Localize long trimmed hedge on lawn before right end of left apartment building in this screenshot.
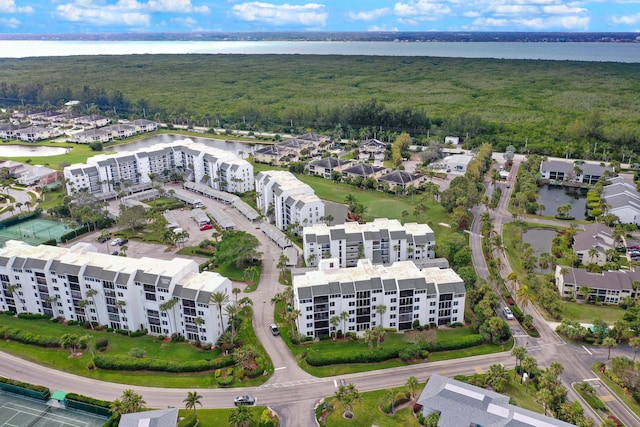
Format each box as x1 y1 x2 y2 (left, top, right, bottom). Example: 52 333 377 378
94 354 234 372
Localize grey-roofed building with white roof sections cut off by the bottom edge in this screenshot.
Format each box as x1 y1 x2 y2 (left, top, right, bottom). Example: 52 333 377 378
418 374 575 427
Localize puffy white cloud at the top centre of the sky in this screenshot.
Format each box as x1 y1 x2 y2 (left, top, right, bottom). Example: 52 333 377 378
232 2 328 27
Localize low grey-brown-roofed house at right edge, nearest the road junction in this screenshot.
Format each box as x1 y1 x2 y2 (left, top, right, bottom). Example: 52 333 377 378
555 265 640 304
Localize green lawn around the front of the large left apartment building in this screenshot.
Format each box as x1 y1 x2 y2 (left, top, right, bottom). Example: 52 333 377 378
0 310 273 388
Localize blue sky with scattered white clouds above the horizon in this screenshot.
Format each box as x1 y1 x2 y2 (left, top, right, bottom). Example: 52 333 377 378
0 0 640 34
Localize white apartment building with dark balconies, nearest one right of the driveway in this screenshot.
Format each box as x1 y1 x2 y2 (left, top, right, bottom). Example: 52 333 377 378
293 259 466 337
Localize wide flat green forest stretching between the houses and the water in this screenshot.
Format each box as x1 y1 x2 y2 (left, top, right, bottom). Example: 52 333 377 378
0 54 640 160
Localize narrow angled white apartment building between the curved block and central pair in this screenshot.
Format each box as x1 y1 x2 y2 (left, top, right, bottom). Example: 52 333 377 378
256 171 324 230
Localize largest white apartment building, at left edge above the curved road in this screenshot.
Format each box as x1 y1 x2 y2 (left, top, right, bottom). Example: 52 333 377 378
0 241 232 343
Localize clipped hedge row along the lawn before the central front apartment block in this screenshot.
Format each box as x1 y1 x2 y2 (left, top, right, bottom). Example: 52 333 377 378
305 334 482 366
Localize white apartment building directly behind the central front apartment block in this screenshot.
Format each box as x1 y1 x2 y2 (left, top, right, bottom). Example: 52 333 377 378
302 218 436 268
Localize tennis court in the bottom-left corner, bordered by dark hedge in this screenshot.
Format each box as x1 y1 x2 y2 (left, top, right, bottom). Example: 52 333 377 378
0 392 107 427
